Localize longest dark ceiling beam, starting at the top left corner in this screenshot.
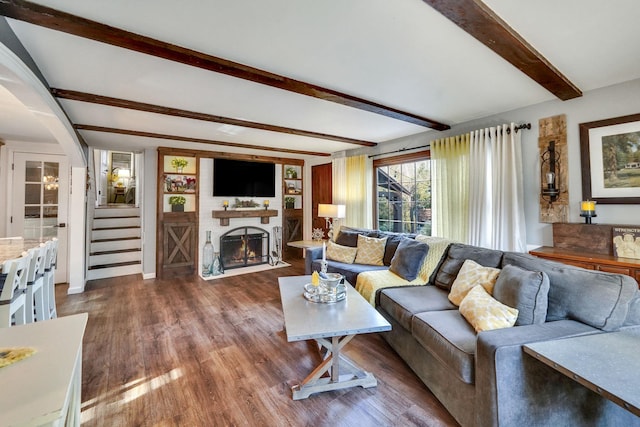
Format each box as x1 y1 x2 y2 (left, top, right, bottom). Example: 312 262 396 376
0 0 449 130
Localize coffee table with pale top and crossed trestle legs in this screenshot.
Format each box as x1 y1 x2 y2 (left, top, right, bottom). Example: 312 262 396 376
278 276 391 400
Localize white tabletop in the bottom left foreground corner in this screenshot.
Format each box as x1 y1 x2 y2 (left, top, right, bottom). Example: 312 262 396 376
0 313 88 426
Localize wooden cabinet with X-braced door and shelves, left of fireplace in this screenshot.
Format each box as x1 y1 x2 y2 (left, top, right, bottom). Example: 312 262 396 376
156 148 198 278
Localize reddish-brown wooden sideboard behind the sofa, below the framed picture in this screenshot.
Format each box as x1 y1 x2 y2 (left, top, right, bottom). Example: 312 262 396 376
529 246 640 286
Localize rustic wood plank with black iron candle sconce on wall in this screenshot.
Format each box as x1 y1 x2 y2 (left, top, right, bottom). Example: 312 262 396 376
538 114 569 223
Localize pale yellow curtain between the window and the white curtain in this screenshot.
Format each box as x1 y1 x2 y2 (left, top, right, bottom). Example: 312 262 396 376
431 133 470 243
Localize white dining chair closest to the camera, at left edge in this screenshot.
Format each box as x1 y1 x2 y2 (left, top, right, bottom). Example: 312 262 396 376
0 253 31 328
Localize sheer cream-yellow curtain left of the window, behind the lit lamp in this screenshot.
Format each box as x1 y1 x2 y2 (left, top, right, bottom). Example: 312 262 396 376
332 155 373 231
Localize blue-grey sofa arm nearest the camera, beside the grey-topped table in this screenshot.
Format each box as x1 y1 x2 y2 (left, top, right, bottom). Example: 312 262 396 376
475 320 607 426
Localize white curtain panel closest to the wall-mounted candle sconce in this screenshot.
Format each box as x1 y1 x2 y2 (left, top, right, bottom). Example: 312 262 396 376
469 123 526 252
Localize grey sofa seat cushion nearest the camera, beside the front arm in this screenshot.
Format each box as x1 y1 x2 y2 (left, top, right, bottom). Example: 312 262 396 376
412 310 476 384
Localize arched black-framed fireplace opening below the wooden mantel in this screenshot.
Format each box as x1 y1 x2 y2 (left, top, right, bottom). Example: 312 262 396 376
220 227 270 270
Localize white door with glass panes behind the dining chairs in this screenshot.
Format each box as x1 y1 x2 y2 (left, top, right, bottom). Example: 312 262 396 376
10 153 69 283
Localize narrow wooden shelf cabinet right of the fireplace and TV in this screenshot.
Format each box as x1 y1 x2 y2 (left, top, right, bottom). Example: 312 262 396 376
282 160 304 259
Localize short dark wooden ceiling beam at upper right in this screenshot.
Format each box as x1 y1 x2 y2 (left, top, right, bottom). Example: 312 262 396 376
423 0 582 101
